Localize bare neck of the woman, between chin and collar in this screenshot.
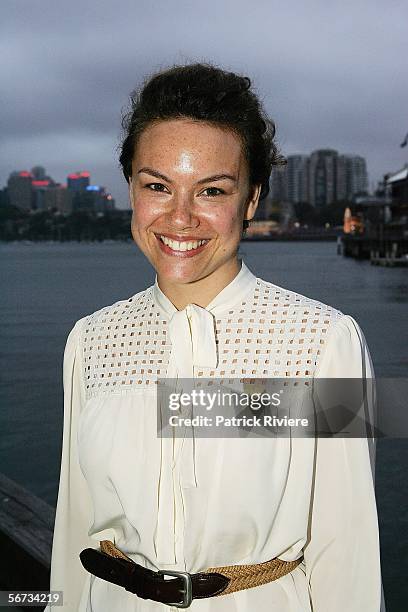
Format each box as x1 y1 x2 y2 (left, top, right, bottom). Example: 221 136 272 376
157 259 241 310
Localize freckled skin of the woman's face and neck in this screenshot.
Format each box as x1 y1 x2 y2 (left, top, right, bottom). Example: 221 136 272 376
129 119 260 310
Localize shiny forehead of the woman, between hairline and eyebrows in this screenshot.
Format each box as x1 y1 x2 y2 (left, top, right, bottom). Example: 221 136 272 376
133 119 246 173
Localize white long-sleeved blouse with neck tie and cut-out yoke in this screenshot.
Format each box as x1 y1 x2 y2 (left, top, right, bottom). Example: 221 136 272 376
46 262 381 612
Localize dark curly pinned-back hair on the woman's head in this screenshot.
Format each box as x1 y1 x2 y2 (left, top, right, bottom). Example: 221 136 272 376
119 63 286 230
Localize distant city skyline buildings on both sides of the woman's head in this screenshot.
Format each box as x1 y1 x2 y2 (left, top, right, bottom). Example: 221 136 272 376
0 147 369 212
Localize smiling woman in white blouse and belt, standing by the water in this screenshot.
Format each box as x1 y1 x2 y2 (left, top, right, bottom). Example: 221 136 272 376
45 64 381 612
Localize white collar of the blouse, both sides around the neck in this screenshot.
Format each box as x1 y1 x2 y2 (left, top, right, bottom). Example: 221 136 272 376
153 260 256 317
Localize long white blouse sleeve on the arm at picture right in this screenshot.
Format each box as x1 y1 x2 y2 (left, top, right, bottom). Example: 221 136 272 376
304 315 385 612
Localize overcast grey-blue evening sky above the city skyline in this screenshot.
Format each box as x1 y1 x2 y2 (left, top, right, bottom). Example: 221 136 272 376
0 0 408 208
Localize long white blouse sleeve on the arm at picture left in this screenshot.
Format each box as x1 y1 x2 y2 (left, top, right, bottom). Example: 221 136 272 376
45 319 95 612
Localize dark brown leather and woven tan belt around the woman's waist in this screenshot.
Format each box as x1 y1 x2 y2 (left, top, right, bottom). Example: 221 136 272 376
95 540 303 607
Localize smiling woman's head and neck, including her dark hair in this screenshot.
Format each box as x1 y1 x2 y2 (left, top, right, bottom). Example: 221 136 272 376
120 64 285 308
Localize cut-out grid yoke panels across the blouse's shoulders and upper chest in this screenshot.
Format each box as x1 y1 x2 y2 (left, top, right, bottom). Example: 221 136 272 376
82 279 343 398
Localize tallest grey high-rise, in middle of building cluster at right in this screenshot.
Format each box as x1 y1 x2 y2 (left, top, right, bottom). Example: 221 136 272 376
309 149 338 208
